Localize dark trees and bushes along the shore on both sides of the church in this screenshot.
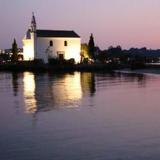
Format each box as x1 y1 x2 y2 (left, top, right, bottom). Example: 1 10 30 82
0 34 160 70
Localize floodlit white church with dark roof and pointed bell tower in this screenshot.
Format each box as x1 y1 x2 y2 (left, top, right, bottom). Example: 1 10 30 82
22 14 81 63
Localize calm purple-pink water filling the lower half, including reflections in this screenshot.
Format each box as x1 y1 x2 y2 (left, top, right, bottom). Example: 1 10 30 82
0 72 160 160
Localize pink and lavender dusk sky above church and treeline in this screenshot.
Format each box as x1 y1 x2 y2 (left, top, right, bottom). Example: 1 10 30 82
0 0 160 49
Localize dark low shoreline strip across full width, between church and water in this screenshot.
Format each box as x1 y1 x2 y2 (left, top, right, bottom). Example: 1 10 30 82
0 62 160 75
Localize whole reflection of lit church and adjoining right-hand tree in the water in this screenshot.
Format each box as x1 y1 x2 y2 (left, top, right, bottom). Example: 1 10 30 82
23 72 95 113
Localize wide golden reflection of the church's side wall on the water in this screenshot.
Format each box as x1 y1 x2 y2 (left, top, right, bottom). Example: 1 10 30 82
52 73 82 108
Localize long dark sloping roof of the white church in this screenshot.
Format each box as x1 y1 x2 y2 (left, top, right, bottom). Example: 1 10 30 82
36 30 80 38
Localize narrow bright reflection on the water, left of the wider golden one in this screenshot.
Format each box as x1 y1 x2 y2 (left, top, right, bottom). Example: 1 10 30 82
23 72 37 113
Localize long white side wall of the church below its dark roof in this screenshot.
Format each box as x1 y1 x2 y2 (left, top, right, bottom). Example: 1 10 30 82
36 37 81 63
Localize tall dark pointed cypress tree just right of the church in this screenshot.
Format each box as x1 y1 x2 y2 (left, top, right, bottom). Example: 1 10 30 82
88 34 95 59
